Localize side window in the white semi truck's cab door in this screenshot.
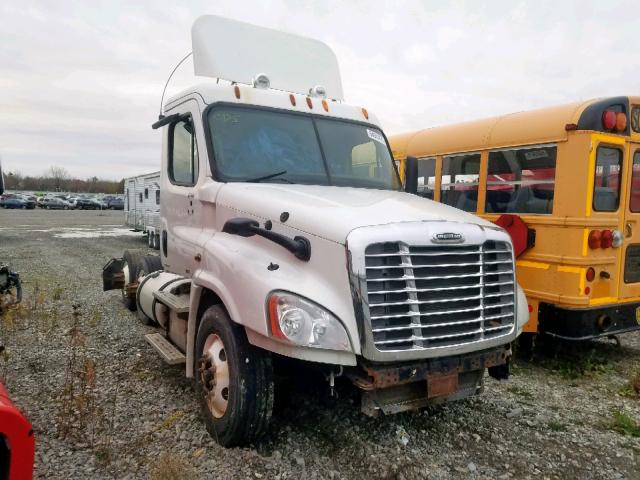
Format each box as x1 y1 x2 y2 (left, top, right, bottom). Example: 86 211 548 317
169 121 198 186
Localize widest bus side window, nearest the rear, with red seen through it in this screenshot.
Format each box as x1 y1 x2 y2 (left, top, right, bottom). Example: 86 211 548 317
485 146 557 214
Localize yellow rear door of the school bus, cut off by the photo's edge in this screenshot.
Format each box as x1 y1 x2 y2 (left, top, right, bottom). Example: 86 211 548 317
620 142 640 299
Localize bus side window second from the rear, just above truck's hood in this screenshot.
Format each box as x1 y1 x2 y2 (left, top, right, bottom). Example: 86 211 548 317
440 153 480 212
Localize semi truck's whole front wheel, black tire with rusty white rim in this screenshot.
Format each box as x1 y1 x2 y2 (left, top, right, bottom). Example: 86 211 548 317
194 305 273 447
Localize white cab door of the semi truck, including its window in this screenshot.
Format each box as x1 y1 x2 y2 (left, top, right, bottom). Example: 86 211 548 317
160 100 202 277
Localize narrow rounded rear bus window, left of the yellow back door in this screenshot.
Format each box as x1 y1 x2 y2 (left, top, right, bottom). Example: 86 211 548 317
593 147 622 212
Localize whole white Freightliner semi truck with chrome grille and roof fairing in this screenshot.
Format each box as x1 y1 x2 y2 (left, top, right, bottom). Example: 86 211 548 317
103 16 528 446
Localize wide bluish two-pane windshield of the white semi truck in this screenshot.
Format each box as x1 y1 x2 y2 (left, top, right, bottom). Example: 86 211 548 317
208 106 400 190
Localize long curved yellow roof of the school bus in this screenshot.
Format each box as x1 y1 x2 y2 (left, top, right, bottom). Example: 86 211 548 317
389 97 640 159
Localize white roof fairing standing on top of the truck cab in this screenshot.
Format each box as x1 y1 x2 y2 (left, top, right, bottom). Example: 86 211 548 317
191 15 344 100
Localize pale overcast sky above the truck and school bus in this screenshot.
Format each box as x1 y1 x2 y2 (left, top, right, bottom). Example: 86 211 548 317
0 0 640 179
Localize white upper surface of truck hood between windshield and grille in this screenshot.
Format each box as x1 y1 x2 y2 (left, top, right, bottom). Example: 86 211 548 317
216 183 494 244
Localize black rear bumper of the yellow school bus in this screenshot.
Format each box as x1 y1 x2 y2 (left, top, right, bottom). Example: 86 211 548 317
538 302 640 340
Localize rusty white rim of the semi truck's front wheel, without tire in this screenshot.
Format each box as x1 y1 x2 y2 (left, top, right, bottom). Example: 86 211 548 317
200 333 229 418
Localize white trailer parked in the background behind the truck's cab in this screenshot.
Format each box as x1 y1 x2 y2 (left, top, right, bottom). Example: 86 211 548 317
124 172 160 250
